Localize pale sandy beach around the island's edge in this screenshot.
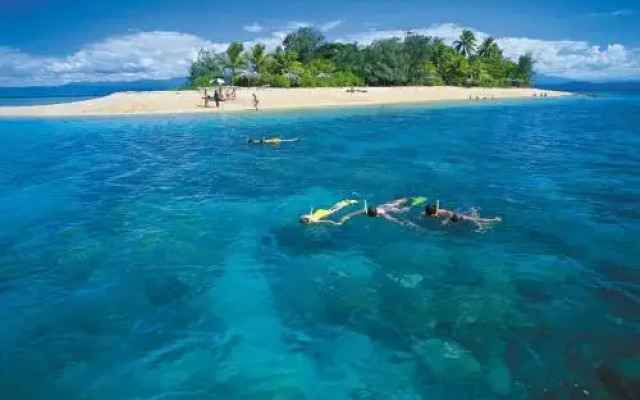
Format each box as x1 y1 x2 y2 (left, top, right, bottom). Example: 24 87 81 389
0 86 572 117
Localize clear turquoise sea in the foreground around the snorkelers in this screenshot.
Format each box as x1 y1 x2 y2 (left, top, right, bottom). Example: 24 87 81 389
0 96 640 400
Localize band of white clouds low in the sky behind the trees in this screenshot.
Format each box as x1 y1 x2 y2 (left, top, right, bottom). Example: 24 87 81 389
0 22 640 86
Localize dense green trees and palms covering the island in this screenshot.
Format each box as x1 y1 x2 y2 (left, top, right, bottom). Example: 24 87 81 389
188 27 534 87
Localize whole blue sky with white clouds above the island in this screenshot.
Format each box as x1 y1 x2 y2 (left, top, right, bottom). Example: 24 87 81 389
0 0 640 86
